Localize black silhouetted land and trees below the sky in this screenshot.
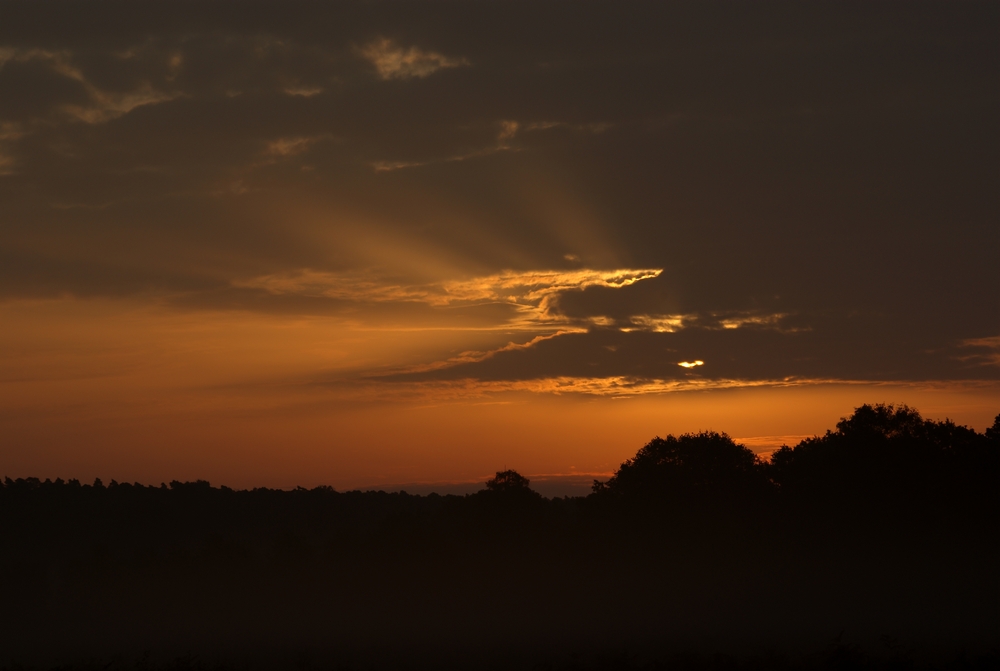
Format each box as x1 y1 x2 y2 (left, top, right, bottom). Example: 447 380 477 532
0 406 1000 669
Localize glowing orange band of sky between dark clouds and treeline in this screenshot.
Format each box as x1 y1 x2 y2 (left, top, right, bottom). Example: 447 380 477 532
0 300 1000 489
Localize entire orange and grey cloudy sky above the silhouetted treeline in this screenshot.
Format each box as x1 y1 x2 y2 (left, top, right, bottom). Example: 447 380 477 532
0 0 1000 494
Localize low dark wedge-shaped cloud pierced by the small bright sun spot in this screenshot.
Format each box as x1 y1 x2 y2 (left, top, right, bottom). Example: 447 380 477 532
381 317 997 383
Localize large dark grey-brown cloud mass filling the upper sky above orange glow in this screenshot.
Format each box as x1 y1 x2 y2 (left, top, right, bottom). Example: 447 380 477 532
0 2 1000 379
